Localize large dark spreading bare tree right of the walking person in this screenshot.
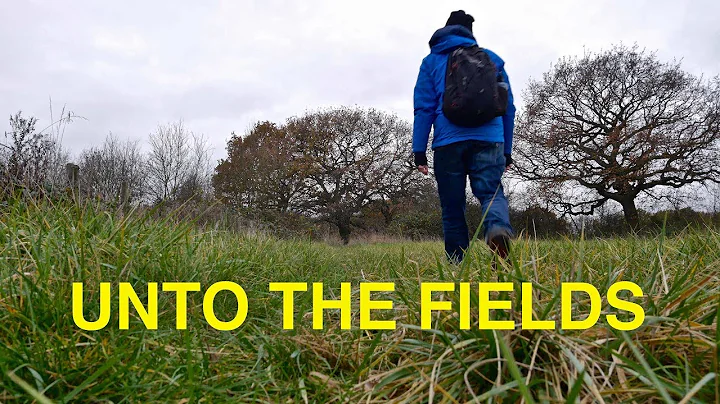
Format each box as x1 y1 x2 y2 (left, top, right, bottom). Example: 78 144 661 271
515 45 720 227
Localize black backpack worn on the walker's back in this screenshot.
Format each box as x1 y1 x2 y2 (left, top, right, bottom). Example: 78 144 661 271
443 45 508 128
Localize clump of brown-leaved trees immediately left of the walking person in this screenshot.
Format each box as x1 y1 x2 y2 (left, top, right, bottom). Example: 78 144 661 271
213 107 422 243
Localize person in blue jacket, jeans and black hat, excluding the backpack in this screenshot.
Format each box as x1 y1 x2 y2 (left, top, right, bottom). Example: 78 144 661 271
413 10 515 263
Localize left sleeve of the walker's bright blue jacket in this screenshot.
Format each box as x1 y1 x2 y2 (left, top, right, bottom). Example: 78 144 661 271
413 58 440 153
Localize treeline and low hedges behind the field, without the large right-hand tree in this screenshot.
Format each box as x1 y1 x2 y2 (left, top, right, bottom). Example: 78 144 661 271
0 108 720 242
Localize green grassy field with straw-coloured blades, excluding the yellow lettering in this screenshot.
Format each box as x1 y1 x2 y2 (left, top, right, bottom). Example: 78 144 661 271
0 197 720 403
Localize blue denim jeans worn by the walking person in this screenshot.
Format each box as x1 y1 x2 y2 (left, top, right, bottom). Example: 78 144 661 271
434 140 512 262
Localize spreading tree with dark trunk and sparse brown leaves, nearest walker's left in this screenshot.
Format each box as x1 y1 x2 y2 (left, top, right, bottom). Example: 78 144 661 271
287 108 417 244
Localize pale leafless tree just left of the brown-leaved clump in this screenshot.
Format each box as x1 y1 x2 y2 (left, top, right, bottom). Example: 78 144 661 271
146 121 210 203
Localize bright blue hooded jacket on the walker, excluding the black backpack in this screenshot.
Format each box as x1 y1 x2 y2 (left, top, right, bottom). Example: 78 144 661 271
413 25 515 154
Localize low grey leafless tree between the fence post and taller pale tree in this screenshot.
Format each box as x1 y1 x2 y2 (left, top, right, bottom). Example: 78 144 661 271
79 133 145 201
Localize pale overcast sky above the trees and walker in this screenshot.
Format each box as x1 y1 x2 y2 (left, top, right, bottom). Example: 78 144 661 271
0 0 720 158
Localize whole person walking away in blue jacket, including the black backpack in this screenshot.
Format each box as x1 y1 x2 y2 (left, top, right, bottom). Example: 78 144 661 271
413 10 515 263
